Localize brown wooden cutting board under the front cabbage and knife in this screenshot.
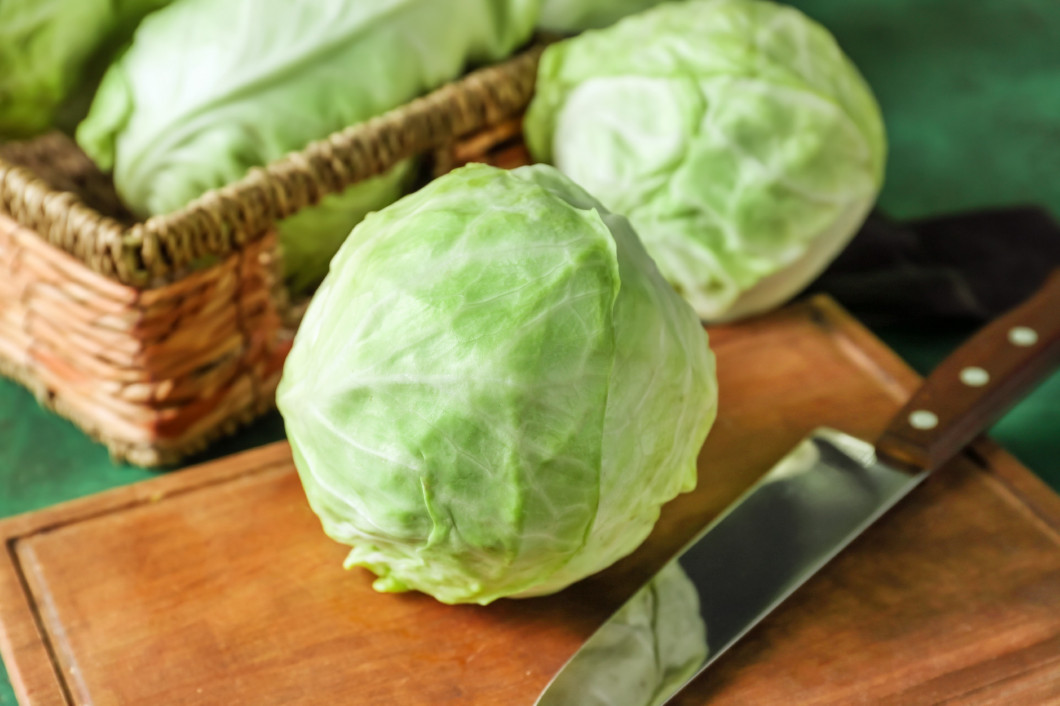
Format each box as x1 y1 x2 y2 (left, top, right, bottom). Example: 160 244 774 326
0 298 1060 706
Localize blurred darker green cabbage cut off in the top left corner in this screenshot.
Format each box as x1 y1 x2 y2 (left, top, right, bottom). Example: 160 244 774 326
0 0 171 139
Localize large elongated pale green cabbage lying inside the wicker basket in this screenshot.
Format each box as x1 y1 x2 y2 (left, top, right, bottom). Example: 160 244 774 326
77 0 537 282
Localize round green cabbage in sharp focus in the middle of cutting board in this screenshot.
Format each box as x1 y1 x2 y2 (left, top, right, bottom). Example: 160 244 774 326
278 164 718 604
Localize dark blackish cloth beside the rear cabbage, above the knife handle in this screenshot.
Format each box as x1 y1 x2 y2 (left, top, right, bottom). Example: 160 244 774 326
806 207 1060 328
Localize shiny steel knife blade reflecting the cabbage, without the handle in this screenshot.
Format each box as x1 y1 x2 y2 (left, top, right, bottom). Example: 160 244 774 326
536 428 928 706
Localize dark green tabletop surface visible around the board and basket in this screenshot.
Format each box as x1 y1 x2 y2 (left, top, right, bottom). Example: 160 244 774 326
0 0 1060 706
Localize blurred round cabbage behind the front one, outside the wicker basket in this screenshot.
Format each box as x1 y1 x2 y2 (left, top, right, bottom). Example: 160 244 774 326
526 0 885 320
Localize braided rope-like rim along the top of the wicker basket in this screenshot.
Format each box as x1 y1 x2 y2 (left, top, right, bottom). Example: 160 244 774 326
0 40 547 287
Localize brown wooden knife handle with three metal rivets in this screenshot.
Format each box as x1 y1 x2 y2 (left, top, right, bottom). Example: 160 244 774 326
876 269 1060 471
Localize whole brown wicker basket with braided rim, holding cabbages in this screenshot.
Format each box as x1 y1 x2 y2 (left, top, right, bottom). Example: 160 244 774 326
0 47 541 466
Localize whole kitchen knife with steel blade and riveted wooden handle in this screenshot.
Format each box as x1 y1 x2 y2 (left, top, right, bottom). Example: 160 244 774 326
536 270 1060 706
